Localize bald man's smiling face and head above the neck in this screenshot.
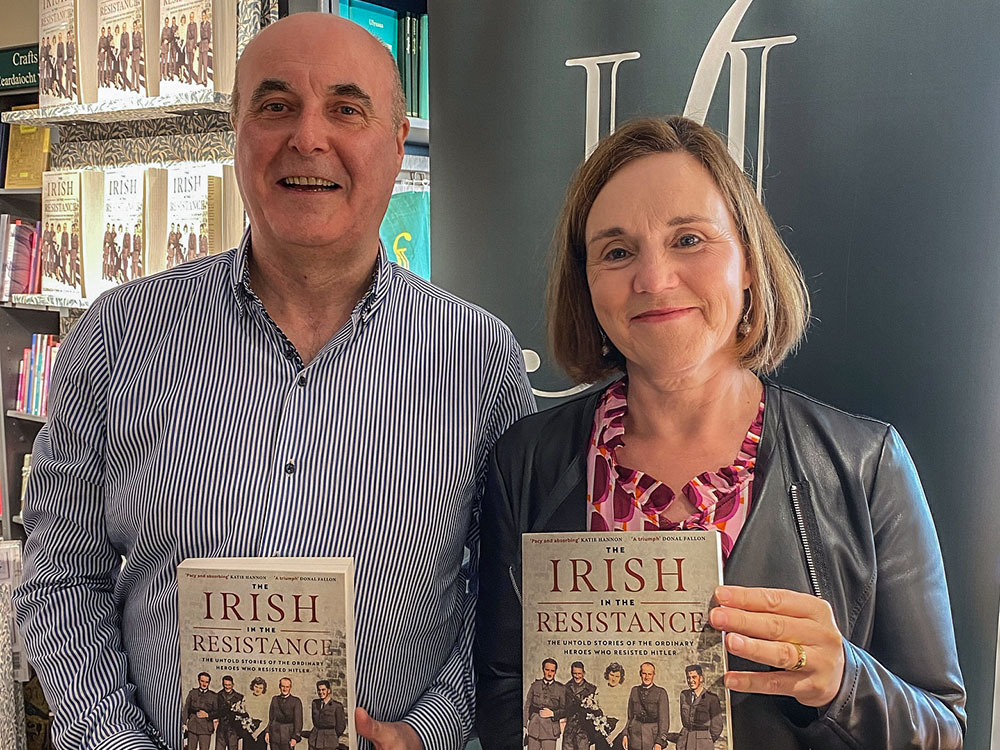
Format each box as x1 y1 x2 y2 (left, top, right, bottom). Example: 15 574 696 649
235 13 409 257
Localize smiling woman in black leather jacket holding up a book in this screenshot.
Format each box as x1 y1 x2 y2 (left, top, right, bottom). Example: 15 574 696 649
476 117 965 750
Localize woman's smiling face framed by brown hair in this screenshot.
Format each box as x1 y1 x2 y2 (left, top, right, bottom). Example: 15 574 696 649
585 152 750 379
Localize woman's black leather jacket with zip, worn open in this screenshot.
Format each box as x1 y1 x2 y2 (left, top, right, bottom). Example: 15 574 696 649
476 383 965 750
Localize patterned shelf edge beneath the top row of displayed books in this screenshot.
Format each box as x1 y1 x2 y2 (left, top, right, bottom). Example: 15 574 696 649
3 90 231 126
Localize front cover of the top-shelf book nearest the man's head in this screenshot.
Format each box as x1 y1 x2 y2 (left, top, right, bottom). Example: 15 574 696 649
160 0 215 94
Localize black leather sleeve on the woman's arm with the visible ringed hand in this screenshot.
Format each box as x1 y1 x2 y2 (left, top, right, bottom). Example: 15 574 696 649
813 427 965 750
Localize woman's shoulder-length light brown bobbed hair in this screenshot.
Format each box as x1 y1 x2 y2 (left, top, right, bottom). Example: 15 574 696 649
547 116 810 383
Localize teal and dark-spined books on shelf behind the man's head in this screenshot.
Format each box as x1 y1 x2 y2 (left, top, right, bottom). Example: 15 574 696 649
340 0 430 119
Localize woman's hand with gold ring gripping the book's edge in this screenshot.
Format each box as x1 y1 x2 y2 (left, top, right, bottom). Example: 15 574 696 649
708 586 844 708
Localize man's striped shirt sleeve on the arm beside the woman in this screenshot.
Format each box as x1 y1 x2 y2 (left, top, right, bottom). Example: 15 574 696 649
403 327 535 750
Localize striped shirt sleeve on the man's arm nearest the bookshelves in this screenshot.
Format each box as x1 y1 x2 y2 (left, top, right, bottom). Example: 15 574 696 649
14 303 163 750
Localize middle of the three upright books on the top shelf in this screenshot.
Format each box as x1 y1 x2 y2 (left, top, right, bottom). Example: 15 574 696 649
92 0 160 102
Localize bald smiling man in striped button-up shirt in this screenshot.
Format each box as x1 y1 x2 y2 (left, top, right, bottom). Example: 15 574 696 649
16 13 532 750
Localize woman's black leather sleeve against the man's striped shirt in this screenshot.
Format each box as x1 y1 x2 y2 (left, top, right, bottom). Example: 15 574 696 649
475 444 527 750
